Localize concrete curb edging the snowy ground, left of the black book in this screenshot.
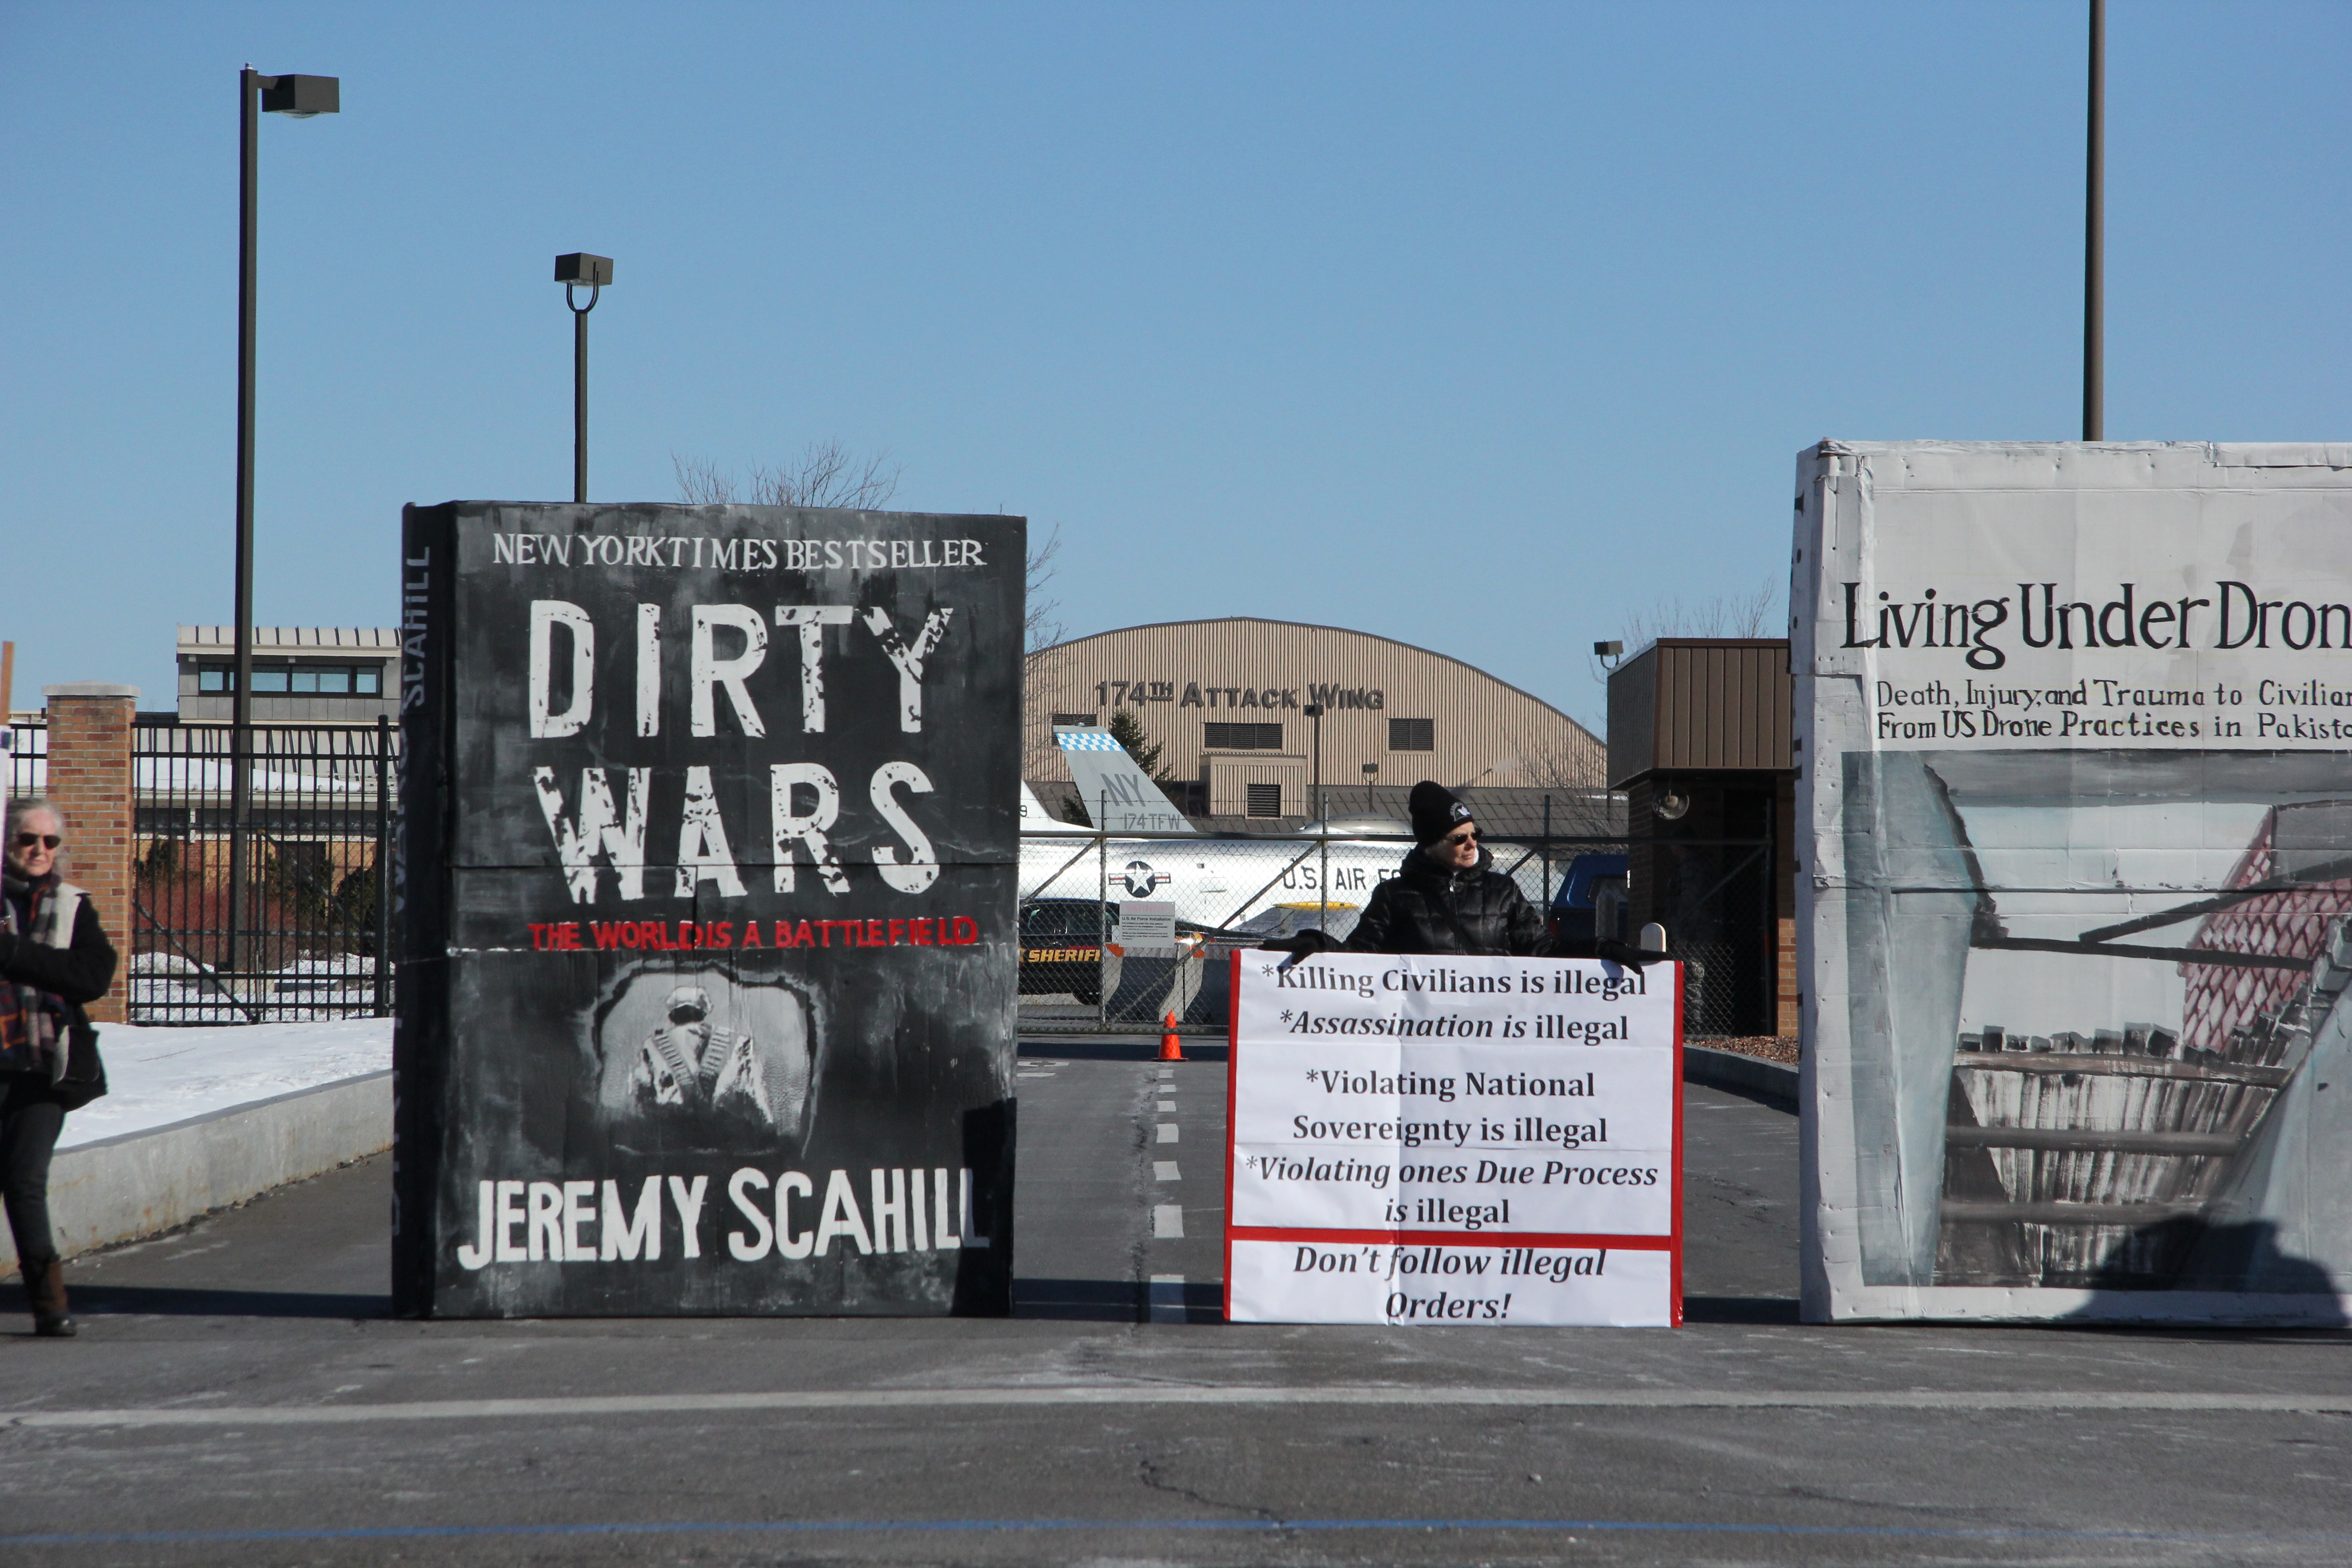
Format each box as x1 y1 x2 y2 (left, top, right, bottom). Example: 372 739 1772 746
0 1070 393 1269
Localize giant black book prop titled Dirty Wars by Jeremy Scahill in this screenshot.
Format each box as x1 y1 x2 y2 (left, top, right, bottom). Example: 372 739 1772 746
393 503 1023 1317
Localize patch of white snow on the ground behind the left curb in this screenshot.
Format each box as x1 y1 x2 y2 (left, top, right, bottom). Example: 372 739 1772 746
56 1018 393 1150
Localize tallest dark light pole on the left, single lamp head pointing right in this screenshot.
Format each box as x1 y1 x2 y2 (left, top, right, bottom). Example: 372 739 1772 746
221 66 343 975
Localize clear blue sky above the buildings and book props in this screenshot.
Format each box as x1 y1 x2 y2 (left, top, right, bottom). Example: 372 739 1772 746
0 0 2352 724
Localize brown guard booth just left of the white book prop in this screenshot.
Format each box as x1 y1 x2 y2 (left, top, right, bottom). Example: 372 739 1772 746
1609 637 1797 1037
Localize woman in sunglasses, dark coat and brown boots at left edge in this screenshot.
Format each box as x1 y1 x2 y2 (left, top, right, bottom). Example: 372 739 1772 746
0 802 115 1338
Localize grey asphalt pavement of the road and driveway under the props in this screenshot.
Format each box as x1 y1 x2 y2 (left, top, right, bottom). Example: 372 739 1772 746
0 1039 2352 1566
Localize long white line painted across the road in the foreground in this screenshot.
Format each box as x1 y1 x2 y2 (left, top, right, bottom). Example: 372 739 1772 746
0 1392 2352 1427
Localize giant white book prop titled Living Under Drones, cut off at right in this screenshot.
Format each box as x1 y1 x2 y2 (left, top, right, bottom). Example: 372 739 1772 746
1790 442 2352 1323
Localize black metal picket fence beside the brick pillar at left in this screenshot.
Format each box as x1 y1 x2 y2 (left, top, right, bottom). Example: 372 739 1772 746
10 722 400 1025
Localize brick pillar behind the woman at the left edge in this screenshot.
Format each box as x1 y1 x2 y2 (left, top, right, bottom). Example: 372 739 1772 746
40 682 139 1023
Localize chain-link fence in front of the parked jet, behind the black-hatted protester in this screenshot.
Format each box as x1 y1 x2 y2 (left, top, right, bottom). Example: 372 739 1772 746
1021 830 1627 1034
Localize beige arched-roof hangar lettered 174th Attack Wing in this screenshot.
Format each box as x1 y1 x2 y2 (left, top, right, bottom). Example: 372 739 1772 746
1021 616 1609 830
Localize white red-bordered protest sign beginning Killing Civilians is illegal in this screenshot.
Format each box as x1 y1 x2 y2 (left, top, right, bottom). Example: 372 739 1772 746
1223 950 1682 1326
